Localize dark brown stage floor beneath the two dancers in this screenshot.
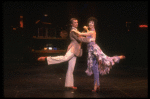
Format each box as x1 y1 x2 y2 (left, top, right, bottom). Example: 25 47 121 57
3 62 148 98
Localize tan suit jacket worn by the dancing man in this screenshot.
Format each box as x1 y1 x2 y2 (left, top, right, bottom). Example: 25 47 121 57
67 29 90 57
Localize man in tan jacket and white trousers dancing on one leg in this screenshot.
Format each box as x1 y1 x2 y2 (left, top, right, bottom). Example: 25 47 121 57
38 18 94 89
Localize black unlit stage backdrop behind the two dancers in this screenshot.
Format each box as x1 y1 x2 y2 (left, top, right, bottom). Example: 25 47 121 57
2 1 148 66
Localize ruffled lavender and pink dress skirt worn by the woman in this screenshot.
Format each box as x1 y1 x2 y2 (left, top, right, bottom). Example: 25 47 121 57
85 36 120 76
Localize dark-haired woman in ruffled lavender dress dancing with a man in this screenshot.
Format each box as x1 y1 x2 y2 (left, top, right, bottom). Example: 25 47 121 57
72 17 125 92
